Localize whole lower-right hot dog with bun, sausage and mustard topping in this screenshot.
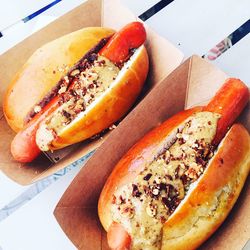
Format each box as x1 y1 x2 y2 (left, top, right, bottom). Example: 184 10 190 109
98 79 250 250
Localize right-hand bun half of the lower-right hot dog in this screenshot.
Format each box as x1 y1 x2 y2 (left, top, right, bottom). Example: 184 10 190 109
162 124 250 250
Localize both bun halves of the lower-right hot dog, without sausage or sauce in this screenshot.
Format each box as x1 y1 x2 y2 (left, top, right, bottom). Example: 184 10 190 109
98 113 250 250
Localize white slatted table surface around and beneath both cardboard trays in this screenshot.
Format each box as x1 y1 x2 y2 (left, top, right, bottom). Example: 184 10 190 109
0 0 250 250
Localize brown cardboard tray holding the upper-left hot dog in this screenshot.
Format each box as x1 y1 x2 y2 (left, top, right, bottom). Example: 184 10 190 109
0 0 183 185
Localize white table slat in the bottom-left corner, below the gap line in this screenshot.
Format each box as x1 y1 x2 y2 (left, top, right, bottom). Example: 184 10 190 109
0 165 79 250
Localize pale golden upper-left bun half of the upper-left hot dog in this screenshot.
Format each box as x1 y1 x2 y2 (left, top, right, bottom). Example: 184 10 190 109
3 27 114 132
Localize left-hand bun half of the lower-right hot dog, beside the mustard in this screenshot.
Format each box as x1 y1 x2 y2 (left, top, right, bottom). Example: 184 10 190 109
98 107 202 231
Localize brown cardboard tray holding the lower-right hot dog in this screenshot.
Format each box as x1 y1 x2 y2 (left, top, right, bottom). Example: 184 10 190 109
54 56 250 250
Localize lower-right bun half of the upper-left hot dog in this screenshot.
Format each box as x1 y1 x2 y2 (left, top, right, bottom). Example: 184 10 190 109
46 46 149 150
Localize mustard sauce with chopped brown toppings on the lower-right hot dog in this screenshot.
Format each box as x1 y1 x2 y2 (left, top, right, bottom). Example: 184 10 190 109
111 112 220 250
